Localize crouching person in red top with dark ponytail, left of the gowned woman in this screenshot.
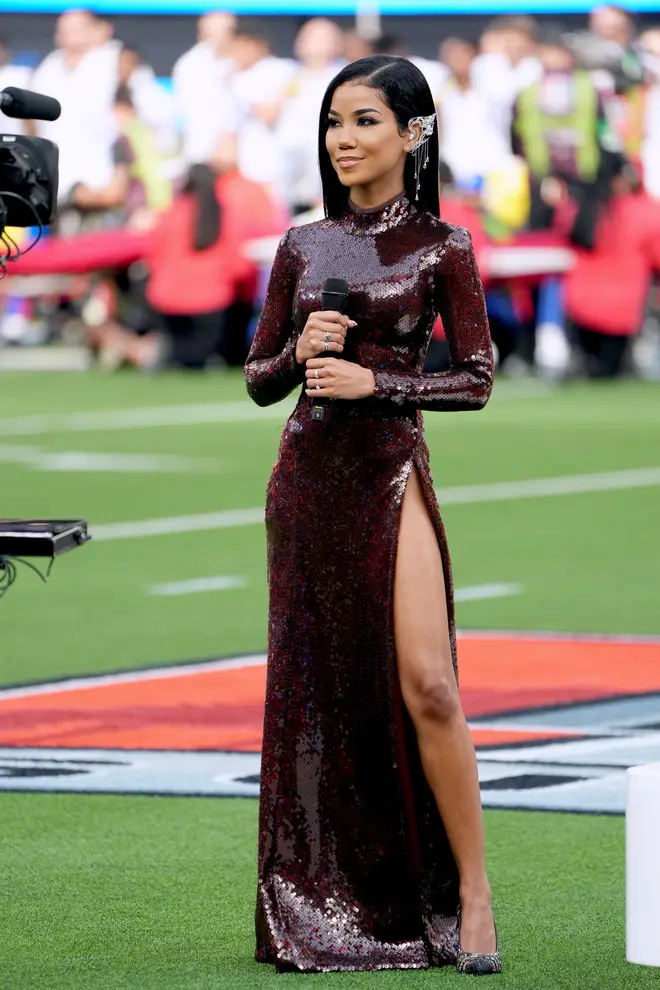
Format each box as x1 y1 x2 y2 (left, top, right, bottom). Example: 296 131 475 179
88 165 288 370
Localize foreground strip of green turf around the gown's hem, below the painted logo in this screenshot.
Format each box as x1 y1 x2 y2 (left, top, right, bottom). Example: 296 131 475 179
0 794 658 990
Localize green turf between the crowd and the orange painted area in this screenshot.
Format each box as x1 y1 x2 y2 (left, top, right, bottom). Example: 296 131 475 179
0 372 660 685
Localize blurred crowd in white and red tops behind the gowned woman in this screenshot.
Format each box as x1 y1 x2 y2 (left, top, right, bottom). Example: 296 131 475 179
0 5 660 375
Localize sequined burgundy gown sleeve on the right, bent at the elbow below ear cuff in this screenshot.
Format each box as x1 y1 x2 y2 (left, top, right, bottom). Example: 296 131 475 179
373 227 493 412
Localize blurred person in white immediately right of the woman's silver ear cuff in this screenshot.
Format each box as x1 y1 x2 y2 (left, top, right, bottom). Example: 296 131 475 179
438 38 511 186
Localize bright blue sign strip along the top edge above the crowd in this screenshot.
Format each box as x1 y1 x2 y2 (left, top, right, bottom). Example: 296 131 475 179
2 0 659 16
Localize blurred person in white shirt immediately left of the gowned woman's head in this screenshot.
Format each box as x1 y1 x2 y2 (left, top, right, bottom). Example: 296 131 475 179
276 17 346 213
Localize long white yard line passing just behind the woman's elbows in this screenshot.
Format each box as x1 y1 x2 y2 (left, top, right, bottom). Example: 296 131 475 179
0 382 556 437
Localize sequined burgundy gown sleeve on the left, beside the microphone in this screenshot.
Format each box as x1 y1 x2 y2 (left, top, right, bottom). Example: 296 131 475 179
245 231 306 406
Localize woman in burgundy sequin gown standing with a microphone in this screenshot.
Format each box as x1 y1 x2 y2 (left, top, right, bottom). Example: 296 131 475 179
245 56 499 972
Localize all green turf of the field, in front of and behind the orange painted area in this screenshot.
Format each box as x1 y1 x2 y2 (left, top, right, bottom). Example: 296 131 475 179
0 374 660 990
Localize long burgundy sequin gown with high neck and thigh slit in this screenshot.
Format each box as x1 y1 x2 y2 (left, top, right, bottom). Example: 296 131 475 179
245 195 492 972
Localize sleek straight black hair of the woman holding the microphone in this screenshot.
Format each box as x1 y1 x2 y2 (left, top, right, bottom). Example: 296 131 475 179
319 55 440 217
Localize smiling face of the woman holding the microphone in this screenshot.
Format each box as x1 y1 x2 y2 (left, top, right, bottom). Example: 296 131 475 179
325 82 412 193
